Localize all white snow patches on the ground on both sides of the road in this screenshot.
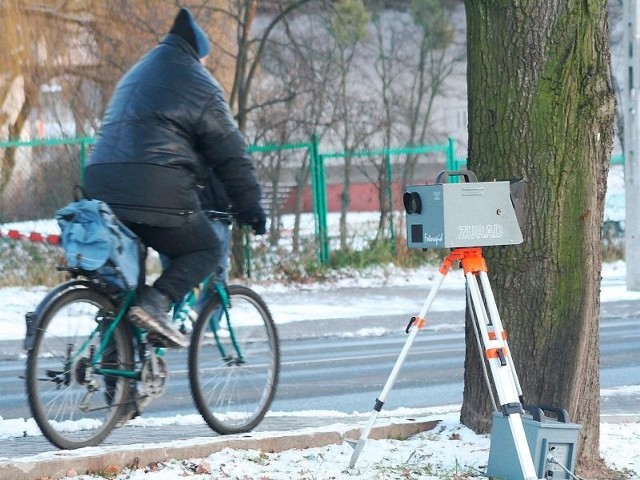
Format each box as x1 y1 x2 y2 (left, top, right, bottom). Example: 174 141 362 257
0 167 640 480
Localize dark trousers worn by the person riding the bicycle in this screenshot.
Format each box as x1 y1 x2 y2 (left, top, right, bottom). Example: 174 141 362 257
127 213 221 302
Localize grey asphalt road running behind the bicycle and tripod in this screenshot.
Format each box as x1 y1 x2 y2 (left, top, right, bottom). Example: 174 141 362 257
0 289 640 456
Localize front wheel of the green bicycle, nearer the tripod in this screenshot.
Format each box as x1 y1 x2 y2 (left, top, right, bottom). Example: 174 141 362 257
189 285 280 435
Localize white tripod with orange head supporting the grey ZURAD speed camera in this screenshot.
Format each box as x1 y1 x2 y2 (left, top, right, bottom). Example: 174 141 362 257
349 248 538 480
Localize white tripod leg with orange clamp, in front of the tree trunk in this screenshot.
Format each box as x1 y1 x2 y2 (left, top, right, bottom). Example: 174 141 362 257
466 271 538 480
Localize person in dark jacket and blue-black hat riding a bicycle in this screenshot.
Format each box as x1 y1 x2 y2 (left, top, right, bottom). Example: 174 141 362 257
84 8 266 347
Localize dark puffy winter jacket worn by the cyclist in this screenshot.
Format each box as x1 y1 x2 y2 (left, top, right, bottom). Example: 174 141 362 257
84 34 261 227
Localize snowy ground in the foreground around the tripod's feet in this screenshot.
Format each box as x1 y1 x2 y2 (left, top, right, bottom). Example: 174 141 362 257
13 408 640 480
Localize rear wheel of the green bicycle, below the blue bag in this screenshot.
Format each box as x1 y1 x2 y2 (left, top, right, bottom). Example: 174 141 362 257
26 288 133 449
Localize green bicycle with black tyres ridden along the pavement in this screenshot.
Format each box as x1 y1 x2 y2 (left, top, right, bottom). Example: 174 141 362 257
24 214 280 449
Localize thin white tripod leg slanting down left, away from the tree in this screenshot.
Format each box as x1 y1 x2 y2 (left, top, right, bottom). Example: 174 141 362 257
349 268 447 468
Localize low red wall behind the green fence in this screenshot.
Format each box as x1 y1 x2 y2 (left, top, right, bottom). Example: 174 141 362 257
280 182 404 213
